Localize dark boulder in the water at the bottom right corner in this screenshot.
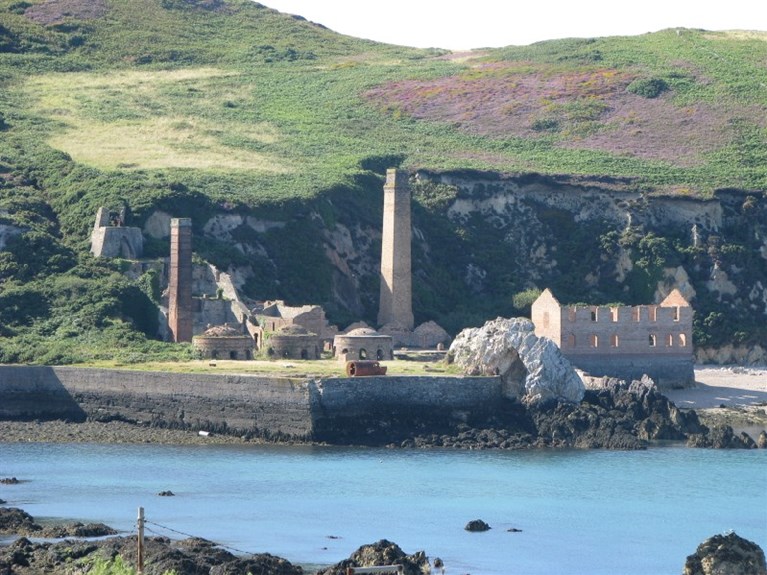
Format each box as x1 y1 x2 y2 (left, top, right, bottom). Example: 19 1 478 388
683 533 767 575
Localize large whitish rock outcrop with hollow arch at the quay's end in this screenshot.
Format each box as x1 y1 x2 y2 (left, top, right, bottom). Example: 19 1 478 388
448 317 584 404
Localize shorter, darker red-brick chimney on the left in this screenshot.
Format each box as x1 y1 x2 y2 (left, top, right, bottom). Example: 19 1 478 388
168 218 194 342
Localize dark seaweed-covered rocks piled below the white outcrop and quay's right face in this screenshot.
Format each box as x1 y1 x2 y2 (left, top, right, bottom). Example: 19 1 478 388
315 379 728 449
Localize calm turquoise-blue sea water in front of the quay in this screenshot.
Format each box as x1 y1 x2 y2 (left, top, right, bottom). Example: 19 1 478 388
0 443 767 575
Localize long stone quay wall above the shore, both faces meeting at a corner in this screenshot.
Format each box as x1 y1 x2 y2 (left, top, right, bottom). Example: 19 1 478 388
0 366 503 438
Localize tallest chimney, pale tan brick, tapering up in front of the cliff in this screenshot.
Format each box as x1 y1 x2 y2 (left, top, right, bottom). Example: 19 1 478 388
378 168 415 330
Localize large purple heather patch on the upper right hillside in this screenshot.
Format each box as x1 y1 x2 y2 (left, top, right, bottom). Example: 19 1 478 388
367 62 765 166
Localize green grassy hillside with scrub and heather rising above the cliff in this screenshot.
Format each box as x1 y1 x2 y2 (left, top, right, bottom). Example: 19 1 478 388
0 0 767 361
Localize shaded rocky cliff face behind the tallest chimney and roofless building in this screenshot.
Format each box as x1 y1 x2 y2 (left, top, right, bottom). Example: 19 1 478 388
145 172 767 363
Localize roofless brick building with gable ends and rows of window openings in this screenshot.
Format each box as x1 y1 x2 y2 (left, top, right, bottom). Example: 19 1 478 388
532 289 695 388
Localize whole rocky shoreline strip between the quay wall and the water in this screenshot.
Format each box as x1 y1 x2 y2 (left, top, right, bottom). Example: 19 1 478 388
0 382 767 449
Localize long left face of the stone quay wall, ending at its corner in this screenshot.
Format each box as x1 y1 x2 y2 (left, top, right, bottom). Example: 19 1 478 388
0 366 312 437
